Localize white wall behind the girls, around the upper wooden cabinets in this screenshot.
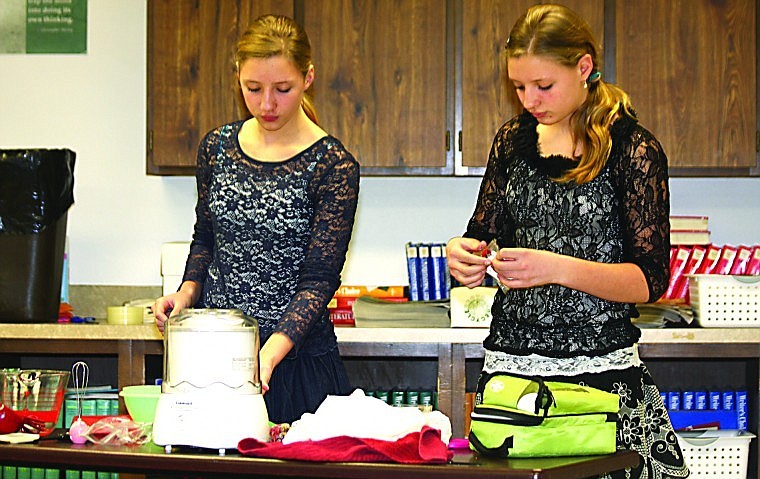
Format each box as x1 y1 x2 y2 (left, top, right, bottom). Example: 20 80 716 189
0 0 760 285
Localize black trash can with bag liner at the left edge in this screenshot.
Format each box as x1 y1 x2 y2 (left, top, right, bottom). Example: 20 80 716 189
0 149 76 323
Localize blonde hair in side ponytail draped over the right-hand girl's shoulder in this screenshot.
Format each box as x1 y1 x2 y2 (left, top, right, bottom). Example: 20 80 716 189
506 4 635 184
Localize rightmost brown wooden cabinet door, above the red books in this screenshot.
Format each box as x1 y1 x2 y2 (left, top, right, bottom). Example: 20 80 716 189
615 0 757 176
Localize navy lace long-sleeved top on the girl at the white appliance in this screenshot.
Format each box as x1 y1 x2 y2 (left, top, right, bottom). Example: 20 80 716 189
183 121 359 354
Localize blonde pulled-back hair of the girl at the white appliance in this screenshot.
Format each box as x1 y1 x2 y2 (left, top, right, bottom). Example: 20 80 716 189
235 15 319 125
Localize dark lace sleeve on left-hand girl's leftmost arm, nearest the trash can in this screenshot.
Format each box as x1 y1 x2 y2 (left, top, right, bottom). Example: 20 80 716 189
182 130 220 286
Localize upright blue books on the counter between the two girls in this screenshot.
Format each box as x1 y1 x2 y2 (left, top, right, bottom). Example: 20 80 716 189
405 242 451 301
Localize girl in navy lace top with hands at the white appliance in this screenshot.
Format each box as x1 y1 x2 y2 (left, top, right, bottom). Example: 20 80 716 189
153 15 359 423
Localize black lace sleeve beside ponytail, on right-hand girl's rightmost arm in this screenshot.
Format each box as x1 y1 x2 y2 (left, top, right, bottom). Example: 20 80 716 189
610 122 670 302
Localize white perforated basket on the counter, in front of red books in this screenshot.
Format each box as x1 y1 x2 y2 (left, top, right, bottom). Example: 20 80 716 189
689 274 760 328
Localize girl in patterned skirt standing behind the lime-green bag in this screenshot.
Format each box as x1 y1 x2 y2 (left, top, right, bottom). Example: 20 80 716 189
447 4 689 479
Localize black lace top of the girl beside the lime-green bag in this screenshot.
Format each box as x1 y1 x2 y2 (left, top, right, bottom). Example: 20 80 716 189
465 112 670 357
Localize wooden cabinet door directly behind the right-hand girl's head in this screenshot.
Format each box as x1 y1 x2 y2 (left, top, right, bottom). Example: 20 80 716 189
456 0 604 175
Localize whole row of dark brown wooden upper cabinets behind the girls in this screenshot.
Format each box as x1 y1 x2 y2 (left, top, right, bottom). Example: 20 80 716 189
147 0 760 176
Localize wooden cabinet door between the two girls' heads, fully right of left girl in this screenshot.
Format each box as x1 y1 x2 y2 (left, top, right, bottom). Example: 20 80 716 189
304 0 452 175
